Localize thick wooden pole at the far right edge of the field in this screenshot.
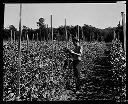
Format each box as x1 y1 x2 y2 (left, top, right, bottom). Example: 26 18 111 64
121 12 126 52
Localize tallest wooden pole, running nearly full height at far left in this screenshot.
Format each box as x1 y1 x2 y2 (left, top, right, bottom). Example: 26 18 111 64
17 4 22 101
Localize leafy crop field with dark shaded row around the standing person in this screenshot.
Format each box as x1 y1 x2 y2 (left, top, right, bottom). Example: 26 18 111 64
3 41 126 101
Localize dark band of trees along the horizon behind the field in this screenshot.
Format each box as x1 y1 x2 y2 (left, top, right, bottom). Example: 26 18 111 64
3 18 124 43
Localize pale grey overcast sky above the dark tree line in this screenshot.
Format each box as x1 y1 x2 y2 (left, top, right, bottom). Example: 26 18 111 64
4 3 126 29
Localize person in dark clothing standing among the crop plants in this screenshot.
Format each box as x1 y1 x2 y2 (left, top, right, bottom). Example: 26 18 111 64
64 38 83 92
